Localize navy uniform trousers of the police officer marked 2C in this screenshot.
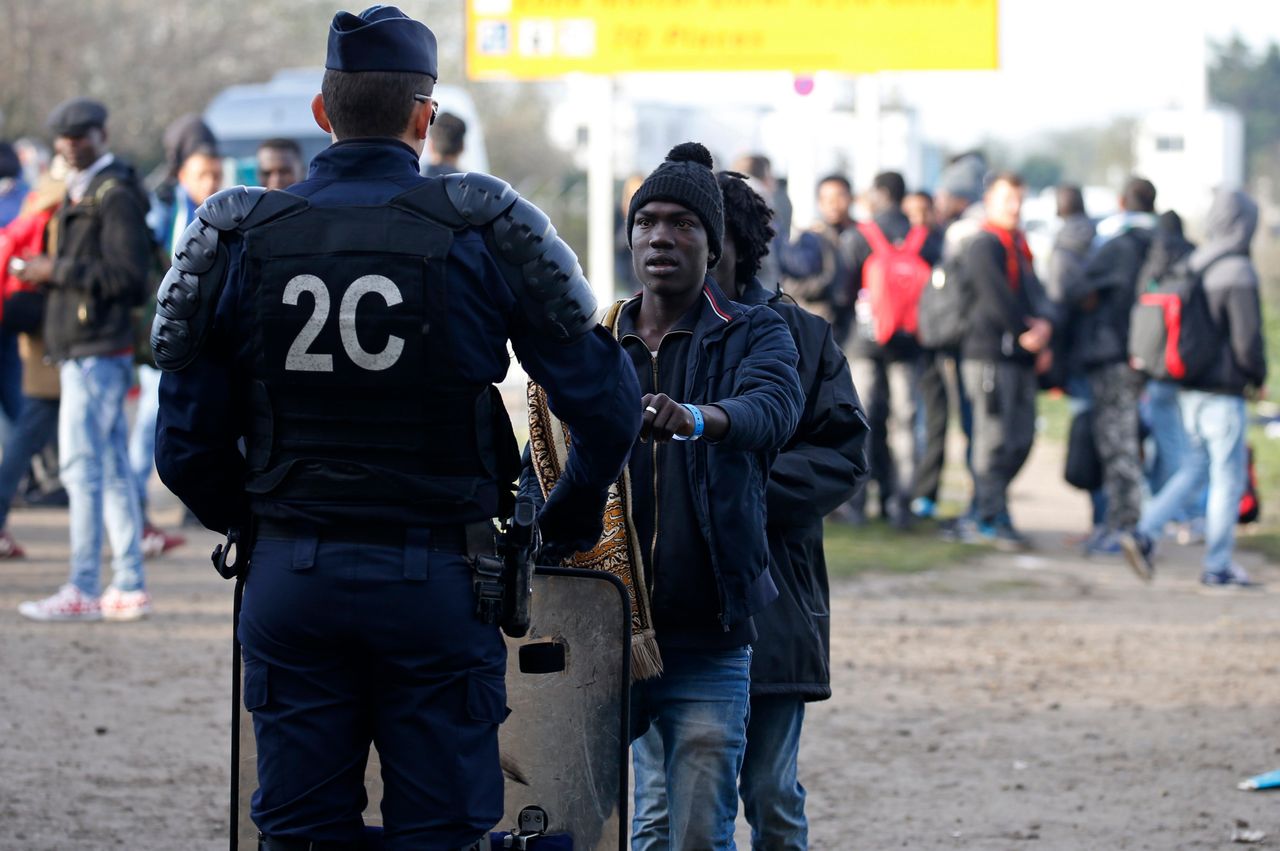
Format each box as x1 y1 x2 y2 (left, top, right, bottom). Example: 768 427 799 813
238 530 507 851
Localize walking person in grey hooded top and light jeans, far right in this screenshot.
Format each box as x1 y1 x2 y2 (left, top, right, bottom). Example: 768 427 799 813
1121 189 1267 587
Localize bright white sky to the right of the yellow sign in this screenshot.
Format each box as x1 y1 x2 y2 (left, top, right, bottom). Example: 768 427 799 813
884 0 1280 143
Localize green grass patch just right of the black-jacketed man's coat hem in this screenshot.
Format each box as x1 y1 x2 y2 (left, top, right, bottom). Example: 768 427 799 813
823 521 991 578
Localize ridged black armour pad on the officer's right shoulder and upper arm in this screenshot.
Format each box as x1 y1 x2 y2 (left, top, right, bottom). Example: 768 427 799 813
442 173 596 343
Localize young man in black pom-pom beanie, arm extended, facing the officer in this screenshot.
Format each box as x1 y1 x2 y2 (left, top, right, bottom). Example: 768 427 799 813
607 143 804 850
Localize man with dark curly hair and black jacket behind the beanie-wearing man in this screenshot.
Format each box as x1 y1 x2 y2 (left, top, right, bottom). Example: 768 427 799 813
632 171 868 850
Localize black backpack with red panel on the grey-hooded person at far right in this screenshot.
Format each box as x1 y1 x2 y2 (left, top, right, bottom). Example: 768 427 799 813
1129 257 1222 384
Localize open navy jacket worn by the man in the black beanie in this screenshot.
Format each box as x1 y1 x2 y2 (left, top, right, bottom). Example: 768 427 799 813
609 278 805 627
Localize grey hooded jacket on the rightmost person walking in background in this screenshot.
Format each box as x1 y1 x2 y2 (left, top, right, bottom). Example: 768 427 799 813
1189 189 1267 395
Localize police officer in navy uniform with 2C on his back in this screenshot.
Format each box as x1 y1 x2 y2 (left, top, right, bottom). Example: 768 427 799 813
152 6 641 851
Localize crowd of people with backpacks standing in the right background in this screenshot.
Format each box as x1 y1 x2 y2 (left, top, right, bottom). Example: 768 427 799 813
745 152 1266 587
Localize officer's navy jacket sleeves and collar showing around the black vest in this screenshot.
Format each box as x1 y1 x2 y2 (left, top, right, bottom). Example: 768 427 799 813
156 139 640 531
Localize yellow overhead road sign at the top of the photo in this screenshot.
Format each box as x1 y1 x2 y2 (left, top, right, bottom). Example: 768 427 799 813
467 0 998 79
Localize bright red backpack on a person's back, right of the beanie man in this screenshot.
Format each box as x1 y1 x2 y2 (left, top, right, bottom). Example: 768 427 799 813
858 221 933 346
